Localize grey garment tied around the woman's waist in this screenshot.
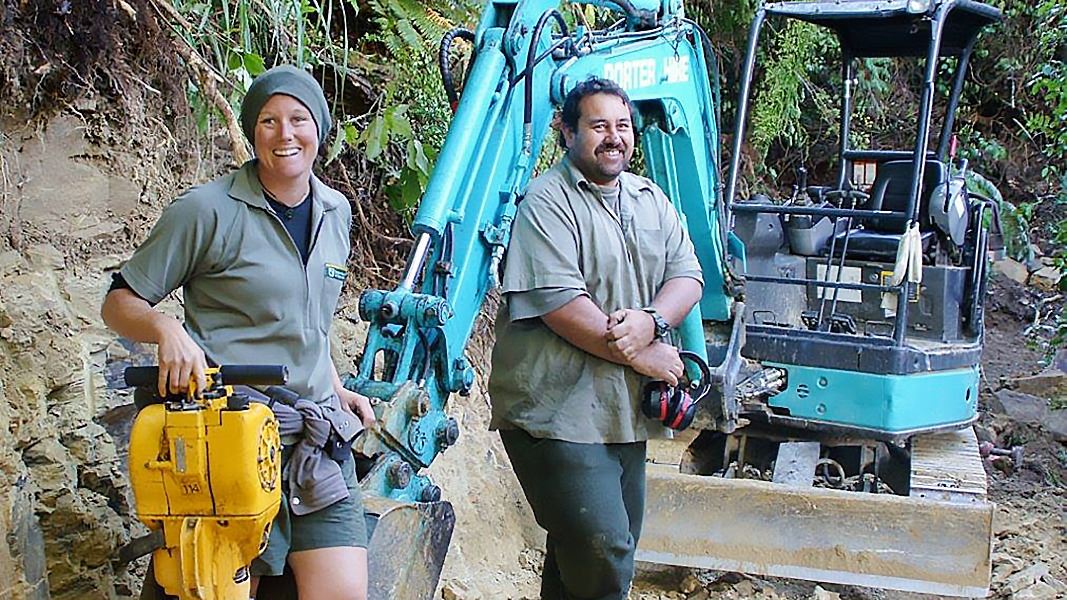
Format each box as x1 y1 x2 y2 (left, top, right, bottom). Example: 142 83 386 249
240 386 363 517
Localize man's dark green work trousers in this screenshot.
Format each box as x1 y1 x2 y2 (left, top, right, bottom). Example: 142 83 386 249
500 429 646 600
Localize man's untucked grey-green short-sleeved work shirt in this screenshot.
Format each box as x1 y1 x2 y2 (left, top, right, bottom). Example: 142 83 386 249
489 159 703 443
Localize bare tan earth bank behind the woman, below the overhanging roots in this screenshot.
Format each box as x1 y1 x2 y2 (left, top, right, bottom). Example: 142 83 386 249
0 110 540 598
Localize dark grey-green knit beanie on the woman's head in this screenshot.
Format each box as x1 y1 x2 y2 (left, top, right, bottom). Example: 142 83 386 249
241 65 332 146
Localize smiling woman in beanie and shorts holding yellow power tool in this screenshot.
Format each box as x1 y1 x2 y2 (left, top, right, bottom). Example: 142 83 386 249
101 66 375 600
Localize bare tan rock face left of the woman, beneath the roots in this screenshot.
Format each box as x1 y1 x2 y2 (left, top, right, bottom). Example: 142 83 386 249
0 93 198 599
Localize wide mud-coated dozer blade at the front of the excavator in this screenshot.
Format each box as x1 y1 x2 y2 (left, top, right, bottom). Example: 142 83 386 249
637 433 993 597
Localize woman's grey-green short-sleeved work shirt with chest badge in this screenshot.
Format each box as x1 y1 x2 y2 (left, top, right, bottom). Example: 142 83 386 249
122 160 352 402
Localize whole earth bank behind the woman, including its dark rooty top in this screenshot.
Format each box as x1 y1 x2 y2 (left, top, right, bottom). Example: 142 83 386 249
0 0 539 599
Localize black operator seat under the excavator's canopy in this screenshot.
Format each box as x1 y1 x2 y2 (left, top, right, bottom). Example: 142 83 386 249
834 160 949 262
